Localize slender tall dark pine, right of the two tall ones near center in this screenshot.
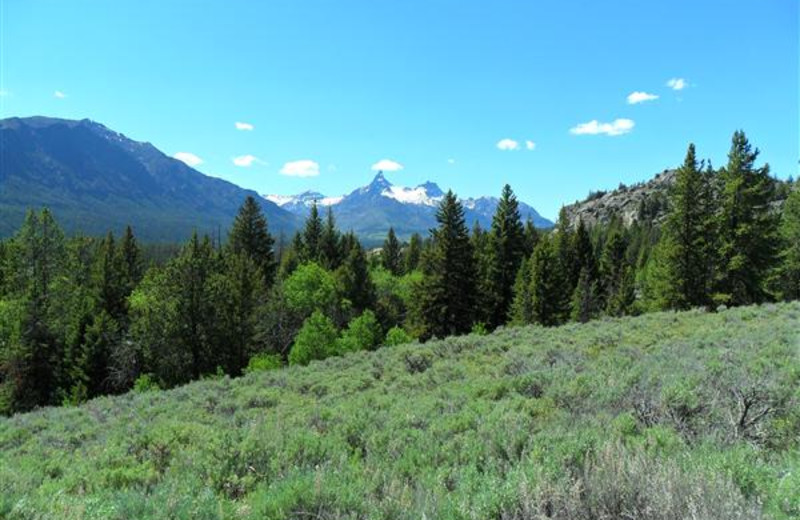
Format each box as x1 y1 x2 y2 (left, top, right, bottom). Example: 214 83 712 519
484 184 526 328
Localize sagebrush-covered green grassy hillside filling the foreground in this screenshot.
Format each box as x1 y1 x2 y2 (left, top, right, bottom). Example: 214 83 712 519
0 303 800 519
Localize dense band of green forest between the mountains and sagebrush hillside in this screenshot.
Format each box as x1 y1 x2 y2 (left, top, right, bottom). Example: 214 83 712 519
0 132 800 414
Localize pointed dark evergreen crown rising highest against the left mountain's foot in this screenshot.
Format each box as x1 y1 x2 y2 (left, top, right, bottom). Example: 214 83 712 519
228 195 278 286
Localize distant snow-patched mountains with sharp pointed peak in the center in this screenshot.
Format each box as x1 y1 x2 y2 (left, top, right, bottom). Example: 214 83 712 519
264 172 553 241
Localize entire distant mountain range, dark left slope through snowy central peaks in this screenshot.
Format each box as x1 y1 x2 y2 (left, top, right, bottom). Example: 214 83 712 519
0 117 552 244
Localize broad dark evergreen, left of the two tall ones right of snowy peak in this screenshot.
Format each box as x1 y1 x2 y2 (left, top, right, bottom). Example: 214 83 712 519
417 191 476 338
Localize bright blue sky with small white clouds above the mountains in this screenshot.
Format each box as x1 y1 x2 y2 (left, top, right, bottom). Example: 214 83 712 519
0 0 800 218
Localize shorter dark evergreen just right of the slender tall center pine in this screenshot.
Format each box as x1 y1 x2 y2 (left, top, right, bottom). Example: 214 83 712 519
530 240 570 326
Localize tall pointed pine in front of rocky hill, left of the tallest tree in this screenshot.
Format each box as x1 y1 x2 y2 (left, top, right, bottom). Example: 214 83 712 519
658 144 713 310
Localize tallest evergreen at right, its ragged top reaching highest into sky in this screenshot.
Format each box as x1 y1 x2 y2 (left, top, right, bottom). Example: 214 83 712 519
716 131 778 305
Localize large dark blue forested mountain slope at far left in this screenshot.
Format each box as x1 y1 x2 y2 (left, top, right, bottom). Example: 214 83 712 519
0 117 299 240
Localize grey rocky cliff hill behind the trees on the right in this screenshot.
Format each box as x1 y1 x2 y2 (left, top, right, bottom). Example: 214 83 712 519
564 170 675 226
